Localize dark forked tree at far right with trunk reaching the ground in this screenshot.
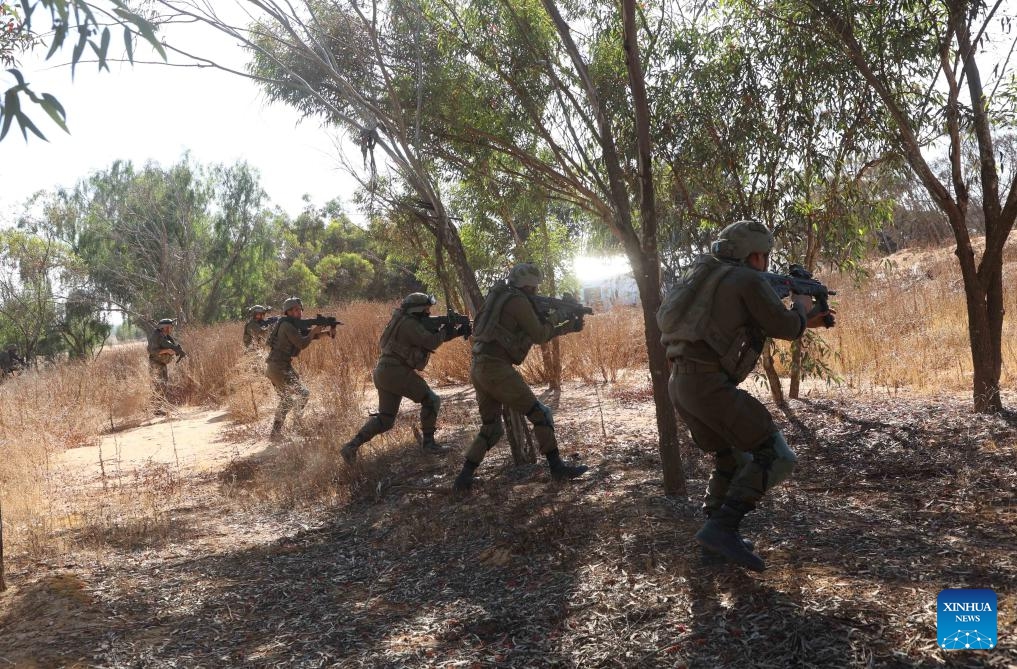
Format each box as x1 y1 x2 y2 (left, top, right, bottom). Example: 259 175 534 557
741 0 1017 412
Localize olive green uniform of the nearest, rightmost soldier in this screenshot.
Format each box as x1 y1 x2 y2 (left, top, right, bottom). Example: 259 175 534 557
658 256 805 515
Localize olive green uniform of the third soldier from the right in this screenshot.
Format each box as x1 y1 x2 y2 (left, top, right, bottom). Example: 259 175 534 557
350 308 444 450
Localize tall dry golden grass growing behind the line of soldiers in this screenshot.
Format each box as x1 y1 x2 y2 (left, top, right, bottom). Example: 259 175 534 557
7 236 1017 558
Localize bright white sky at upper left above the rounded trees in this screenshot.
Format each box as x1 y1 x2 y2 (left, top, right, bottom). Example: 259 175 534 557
0 5 360 225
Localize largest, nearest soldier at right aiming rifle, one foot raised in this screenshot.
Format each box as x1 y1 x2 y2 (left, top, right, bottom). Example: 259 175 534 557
657 221 830 571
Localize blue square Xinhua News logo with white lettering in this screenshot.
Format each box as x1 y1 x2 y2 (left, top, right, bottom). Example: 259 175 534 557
936 589 999 651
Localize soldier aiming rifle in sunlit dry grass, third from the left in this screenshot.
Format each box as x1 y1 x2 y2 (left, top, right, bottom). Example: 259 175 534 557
264 297 323 441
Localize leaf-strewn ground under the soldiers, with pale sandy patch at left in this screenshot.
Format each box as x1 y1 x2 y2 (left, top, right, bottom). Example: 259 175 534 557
0 384 1017 668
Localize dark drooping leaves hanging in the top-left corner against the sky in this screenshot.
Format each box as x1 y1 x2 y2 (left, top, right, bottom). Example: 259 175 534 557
0 0 166 141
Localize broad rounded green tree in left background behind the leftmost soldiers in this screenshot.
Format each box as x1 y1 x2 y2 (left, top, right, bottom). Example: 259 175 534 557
42 159 276 323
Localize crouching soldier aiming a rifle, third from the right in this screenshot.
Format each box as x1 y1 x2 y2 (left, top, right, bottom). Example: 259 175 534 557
340 293 469 465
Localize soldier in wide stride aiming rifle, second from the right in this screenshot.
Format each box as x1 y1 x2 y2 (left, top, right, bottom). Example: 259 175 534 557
453 262 588 494
